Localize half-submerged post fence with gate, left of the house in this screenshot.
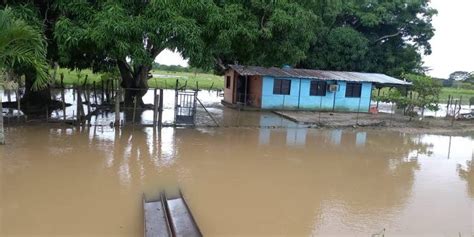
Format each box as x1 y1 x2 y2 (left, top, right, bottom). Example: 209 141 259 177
3 79 224 127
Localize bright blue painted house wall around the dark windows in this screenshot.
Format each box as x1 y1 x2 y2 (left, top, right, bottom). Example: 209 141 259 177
262 77 372 112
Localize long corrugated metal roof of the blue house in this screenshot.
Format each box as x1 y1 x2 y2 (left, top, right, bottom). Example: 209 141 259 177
229 65 411 85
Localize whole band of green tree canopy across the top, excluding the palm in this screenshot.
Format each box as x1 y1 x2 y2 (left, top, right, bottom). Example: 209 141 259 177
4 0 436 91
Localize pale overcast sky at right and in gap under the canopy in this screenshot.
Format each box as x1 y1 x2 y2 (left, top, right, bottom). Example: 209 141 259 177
155 0 474 78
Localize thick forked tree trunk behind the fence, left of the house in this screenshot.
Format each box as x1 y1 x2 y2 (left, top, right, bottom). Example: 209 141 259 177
117 60 151 107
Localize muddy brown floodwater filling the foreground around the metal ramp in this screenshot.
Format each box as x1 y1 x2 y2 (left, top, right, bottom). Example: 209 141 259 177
0 124 474 236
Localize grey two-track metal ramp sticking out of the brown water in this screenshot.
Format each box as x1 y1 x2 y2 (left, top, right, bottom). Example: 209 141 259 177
143 191 202 237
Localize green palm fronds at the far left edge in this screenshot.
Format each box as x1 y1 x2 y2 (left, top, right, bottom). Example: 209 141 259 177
0 7 49 89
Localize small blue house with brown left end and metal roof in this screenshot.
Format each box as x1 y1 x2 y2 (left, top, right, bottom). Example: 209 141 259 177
222 65 411 112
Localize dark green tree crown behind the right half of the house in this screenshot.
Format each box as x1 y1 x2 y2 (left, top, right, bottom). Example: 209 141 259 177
299 0 436 76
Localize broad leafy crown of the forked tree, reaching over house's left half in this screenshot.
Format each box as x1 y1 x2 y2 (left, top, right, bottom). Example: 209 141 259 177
54 0 316 103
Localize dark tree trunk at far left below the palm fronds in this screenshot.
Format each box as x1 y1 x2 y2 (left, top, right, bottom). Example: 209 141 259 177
21 71 51 115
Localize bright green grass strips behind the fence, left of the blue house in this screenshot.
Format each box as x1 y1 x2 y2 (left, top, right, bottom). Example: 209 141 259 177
51 68 224 90
